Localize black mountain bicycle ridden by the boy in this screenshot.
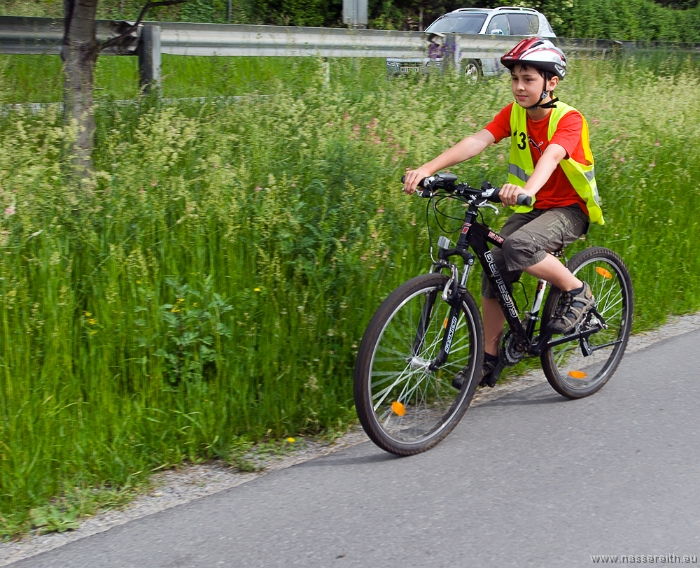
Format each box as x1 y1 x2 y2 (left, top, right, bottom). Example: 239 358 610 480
354 174 634 456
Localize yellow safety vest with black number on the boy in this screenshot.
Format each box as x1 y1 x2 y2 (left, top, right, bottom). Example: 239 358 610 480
508 102 605 225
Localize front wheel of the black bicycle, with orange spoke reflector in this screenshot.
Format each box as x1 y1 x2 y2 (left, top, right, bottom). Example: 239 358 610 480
354 273 484 456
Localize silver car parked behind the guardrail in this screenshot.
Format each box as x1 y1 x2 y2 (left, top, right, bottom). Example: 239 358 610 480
386 7 556 81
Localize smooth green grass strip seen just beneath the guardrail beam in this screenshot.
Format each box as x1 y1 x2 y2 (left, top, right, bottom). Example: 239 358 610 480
0 55 386 103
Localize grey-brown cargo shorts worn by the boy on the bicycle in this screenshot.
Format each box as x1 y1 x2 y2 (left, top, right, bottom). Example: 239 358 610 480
481 205 589 298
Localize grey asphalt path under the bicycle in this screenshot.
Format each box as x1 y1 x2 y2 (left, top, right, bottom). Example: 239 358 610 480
12 332 700 568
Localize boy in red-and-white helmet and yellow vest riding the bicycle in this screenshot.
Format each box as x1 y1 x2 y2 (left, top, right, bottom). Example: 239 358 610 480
404 38 603 388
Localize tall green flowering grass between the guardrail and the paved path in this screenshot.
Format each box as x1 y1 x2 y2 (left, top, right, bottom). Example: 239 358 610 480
0 54 700 535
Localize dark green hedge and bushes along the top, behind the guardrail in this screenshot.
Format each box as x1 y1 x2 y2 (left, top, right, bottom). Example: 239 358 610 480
0 0 700 42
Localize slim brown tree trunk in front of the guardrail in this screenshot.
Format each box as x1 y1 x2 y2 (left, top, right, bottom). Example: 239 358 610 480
61 0 99 173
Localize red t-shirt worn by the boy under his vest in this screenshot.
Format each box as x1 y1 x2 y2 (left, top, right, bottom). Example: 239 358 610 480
486 103 588 215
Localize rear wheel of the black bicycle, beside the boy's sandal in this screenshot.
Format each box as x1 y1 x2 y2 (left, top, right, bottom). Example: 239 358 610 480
540 247 634 399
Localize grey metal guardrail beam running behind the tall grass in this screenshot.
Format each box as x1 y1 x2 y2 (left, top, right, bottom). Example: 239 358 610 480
0 16 615 58
